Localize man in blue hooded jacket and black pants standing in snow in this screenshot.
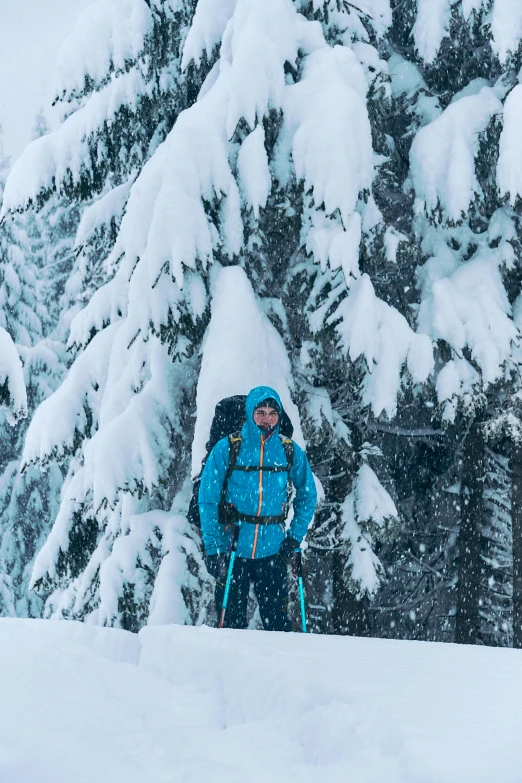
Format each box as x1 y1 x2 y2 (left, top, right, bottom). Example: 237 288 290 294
198 386 317 631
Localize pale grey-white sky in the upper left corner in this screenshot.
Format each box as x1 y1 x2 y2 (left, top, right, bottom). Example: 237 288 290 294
0 0 93 159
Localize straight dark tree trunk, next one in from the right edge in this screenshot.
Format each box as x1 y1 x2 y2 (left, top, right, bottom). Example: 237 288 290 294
455 419 484 644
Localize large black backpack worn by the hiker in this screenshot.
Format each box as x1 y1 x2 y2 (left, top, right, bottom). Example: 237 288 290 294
188 394 294 528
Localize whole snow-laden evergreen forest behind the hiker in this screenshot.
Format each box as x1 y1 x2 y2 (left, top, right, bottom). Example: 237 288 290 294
0 0 522 646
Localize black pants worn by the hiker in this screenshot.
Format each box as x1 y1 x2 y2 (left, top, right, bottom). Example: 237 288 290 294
215 555 292 631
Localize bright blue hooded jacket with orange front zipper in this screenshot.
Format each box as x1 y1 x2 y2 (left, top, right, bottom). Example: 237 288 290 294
198 386 317 559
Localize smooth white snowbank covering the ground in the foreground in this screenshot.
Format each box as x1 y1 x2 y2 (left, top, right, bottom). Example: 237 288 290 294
0 619 522 783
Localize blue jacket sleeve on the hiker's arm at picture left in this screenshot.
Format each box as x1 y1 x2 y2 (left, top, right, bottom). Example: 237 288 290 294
198 438 230 555
